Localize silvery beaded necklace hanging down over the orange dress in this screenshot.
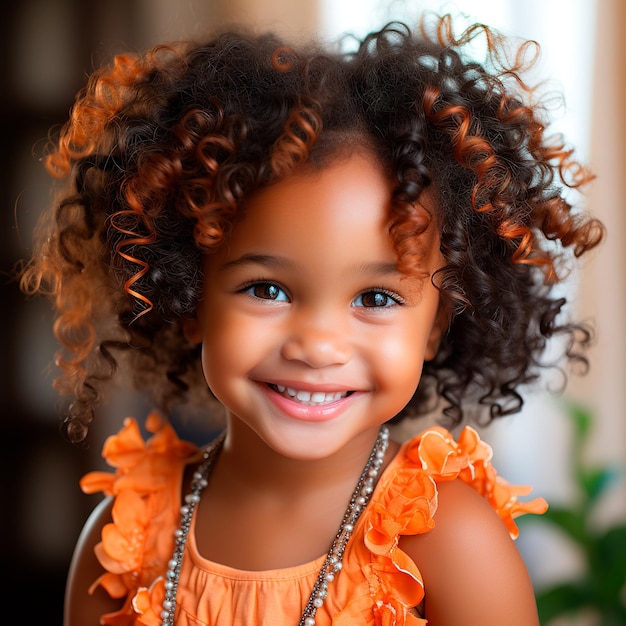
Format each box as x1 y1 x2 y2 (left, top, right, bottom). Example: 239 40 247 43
161 426 389 626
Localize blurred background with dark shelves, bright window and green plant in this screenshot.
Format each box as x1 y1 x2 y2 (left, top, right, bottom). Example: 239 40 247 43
0 0 626 626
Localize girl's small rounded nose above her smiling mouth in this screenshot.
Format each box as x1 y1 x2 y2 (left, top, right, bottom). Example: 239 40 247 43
281 311 352 369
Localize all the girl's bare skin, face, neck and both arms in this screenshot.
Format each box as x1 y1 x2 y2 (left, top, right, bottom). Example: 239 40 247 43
65 151 538 626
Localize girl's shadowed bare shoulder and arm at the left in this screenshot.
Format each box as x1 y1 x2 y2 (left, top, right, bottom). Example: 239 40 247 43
63 498 121 626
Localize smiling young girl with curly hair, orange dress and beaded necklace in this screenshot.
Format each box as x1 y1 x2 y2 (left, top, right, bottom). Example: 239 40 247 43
22 11 602 626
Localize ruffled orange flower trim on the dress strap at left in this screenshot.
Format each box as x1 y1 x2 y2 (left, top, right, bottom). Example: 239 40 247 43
80 413 198 626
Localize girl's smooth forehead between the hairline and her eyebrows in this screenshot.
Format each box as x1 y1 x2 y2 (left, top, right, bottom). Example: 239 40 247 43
205 150 443 276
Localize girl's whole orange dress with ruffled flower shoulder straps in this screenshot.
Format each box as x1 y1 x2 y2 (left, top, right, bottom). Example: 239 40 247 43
81 413 547 626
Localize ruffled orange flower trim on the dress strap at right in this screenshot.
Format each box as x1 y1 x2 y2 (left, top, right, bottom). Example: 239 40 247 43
333 427 548 626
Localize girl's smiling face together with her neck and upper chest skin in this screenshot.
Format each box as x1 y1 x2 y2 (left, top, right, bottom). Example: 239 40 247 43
187 150 442 569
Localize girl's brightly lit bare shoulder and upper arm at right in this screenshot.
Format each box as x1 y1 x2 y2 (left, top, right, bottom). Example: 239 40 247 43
401 480 539 626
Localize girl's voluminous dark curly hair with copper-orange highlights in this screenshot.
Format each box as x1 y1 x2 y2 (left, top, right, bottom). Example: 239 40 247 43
21 15 603 442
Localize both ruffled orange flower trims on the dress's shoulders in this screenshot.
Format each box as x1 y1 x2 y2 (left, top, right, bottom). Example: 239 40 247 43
81 413 547 626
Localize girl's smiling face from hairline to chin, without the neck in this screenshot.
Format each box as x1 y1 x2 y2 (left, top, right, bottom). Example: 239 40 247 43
187 149 442 459
